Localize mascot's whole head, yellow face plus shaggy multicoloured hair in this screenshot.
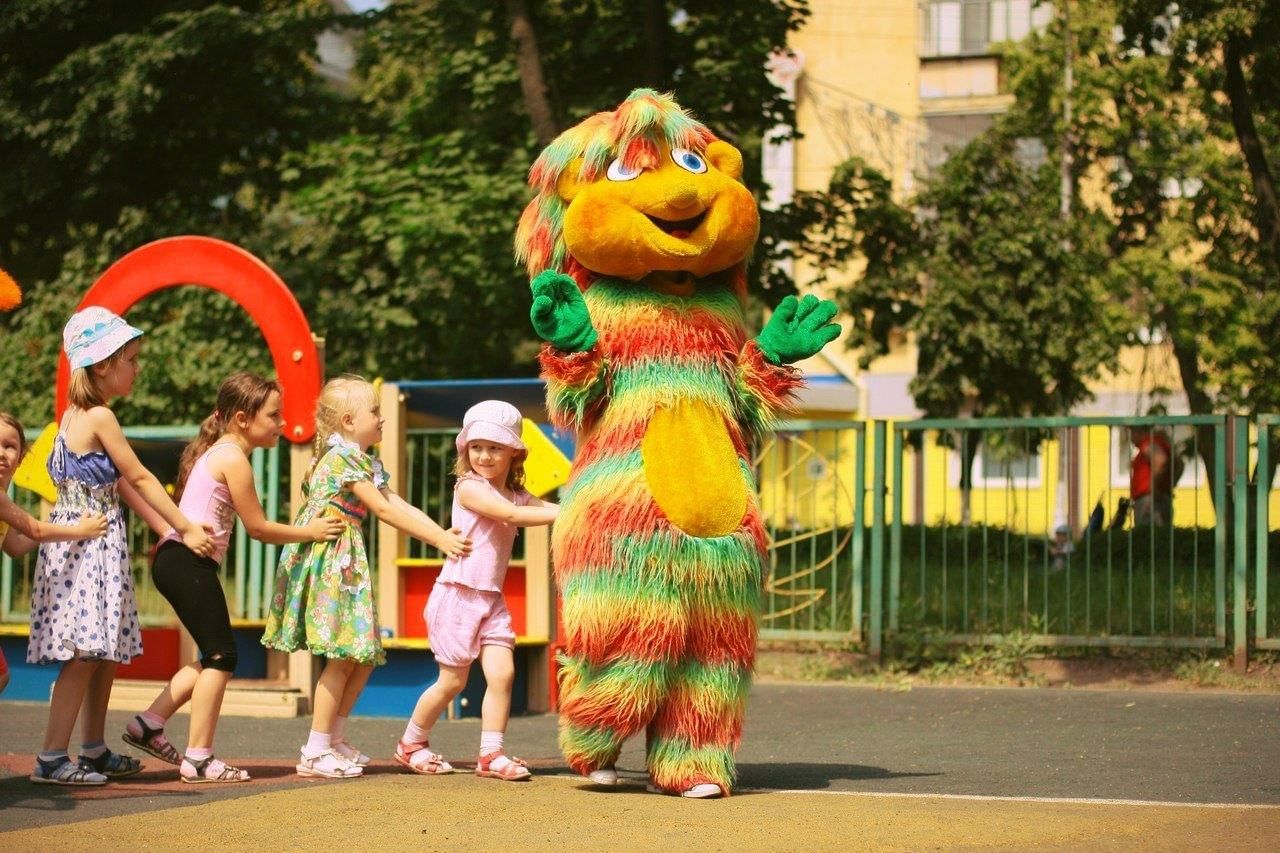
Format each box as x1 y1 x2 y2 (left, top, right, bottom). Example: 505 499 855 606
516 90 760 287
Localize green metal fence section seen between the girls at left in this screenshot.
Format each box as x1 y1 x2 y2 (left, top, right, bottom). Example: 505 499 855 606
0 427 291 625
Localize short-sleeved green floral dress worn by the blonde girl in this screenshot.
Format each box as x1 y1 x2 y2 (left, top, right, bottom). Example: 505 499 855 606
262 435 387 663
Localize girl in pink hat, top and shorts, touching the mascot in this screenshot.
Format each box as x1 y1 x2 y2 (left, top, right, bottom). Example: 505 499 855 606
396 400 559 781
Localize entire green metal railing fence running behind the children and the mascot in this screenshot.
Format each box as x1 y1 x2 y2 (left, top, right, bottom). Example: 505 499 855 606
10 415 1280 656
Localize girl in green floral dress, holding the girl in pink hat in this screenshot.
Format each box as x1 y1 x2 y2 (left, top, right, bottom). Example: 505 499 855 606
262 377 471 779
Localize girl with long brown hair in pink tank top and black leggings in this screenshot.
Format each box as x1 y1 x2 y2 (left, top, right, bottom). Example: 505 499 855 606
123 373 347 783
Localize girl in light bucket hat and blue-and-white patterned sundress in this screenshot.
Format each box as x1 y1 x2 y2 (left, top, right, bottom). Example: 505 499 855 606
27 306 214 785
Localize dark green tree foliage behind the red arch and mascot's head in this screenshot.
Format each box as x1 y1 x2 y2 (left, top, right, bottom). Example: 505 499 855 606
0 0 806 425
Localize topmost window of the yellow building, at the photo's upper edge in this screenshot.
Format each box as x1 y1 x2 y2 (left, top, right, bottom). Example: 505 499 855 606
920 0 1053 56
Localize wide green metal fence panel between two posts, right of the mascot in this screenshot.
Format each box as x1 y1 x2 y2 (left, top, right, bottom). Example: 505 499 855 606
884 416 1229 648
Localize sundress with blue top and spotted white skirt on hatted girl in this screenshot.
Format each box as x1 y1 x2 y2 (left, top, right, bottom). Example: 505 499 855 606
27 432 142 663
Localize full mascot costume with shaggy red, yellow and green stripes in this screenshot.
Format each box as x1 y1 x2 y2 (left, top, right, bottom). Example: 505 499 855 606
516 90 838 797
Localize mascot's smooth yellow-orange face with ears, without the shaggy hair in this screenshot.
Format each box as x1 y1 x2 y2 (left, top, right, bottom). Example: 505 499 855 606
557 140 759 280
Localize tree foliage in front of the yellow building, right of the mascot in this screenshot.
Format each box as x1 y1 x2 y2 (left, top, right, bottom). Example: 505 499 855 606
792 0 1280 435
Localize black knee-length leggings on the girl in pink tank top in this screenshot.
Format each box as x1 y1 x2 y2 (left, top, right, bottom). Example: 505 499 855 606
151 540 237 672
